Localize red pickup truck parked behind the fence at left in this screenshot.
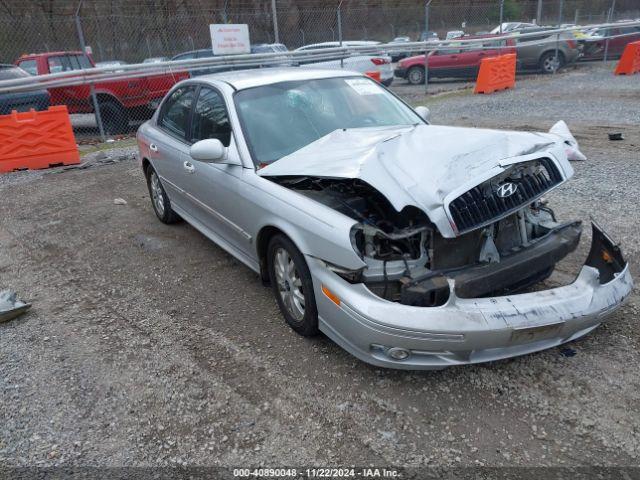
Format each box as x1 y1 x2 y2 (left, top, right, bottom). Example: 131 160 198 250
15 52 189 134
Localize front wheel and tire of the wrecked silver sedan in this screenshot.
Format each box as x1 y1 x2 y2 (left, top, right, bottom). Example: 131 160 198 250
267 235 319 337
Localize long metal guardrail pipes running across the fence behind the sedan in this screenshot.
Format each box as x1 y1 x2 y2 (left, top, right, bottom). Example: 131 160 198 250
0 21 640 93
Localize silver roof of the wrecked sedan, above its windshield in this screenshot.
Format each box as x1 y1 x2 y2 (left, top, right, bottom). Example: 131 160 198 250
192 67 363 90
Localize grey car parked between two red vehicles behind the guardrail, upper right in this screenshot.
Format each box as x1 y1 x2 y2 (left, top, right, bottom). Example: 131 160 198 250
516 27 582 73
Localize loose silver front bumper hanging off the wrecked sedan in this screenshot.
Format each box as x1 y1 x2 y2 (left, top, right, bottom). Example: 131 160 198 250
307 224 633 370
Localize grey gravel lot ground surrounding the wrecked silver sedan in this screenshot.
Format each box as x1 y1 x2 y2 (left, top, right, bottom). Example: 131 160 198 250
0 64 640 467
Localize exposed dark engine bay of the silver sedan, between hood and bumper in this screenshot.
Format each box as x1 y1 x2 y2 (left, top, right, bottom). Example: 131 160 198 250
272 175 582 307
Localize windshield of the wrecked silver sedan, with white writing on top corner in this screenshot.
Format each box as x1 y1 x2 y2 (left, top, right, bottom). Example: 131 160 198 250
235 77 423 165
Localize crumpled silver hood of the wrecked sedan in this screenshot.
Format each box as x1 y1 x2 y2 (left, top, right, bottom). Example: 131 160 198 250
258 125 573 237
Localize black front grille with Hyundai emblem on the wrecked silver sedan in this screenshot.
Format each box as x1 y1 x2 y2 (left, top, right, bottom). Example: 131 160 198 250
449 158 562 233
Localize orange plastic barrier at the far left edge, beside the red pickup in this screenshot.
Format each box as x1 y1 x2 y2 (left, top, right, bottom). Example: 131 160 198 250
0 105 80 173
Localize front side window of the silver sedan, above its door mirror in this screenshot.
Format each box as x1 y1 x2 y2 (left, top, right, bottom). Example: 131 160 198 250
191 87 231 147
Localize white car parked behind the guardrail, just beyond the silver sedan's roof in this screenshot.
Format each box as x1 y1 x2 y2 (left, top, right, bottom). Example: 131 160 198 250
295 40 393 87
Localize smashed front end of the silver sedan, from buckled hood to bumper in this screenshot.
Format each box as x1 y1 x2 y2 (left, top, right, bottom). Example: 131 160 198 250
260 121 633 369
